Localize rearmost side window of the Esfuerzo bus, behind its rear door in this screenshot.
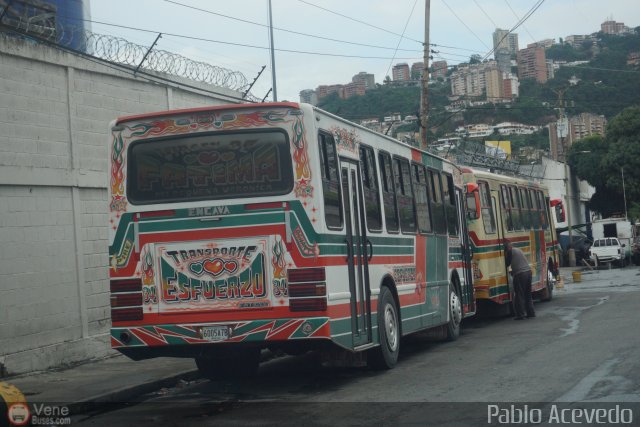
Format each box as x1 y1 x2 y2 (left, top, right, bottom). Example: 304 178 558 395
318 133 342 229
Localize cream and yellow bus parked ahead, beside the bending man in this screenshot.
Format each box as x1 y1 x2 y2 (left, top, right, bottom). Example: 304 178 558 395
463 167 564 312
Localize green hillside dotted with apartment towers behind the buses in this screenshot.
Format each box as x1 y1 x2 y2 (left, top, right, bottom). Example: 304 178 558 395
300 21 640 163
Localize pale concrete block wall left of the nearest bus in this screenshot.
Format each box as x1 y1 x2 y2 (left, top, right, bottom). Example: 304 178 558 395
0 35 240 376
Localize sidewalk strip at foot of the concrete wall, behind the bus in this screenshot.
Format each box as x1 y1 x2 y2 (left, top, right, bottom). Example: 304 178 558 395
0 355 198 414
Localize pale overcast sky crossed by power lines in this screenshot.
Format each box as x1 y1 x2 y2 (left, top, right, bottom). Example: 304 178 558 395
91 0 640 101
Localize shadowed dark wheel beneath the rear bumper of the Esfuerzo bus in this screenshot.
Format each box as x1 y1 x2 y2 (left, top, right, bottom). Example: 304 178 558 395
196 347 260 380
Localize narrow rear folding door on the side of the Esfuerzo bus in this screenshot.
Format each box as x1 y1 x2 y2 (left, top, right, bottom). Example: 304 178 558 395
340 159 371 347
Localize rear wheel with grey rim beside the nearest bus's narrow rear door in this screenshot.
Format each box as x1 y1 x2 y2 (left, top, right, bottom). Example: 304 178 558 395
368 286 400 369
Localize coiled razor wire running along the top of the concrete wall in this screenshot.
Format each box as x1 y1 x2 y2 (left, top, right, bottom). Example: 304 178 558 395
0 0 254 98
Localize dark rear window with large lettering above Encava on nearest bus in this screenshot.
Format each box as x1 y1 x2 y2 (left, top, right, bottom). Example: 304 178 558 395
127 130 293 204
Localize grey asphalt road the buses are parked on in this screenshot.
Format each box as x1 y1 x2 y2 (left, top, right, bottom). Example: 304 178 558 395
74 267 640 426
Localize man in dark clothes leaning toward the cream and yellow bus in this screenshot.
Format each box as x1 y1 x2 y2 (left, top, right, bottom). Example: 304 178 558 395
504 240 536 320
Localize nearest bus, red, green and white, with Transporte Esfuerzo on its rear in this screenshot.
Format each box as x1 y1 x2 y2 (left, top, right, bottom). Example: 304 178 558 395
109 102 475 378
